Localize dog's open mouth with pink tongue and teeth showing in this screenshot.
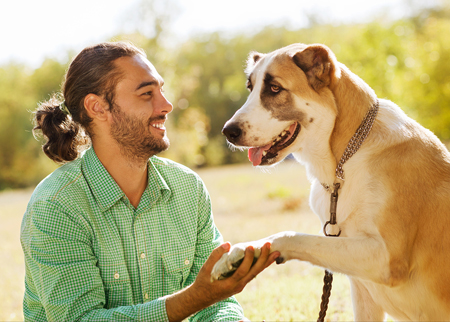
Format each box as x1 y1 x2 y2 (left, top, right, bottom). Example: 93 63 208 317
248 122 301 166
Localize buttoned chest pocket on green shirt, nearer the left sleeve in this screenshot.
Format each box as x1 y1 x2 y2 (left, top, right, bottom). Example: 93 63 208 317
99 262 134 309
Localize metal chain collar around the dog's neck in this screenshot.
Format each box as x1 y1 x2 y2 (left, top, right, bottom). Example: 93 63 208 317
336 100 380 180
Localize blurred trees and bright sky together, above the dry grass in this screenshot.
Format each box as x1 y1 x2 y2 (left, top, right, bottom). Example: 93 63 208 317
0 0 450 189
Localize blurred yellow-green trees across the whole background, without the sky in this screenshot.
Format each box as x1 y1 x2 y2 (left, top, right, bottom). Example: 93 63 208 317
0 7 450 189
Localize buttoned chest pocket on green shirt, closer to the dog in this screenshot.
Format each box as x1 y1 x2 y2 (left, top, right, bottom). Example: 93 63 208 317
161 247 195 295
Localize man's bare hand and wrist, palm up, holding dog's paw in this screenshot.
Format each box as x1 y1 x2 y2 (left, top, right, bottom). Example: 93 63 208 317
166 242 280 321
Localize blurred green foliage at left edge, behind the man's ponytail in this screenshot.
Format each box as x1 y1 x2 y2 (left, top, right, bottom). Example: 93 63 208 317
0 61 64 190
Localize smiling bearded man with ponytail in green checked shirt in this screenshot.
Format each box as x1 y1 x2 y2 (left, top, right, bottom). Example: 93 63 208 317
21 43 279 321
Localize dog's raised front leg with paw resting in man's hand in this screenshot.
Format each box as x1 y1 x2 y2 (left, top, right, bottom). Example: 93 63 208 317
212 232 391 284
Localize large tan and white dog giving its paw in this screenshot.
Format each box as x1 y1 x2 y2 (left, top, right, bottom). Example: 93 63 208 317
212 44 450 321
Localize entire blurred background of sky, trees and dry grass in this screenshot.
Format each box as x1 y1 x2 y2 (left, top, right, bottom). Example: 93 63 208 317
0 0 450 321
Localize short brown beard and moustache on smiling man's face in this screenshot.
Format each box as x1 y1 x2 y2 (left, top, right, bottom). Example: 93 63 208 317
111 105 170 162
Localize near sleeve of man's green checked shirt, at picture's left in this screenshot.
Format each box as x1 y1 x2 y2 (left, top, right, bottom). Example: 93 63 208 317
21 201 168 321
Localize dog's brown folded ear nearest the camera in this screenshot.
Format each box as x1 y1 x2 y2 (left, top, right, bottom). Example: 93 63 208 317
292 45 337 91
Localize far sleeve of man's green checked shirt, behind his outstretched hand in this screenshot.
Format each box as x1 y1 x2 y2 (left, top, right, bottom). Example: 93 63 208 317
186 180 245 322
